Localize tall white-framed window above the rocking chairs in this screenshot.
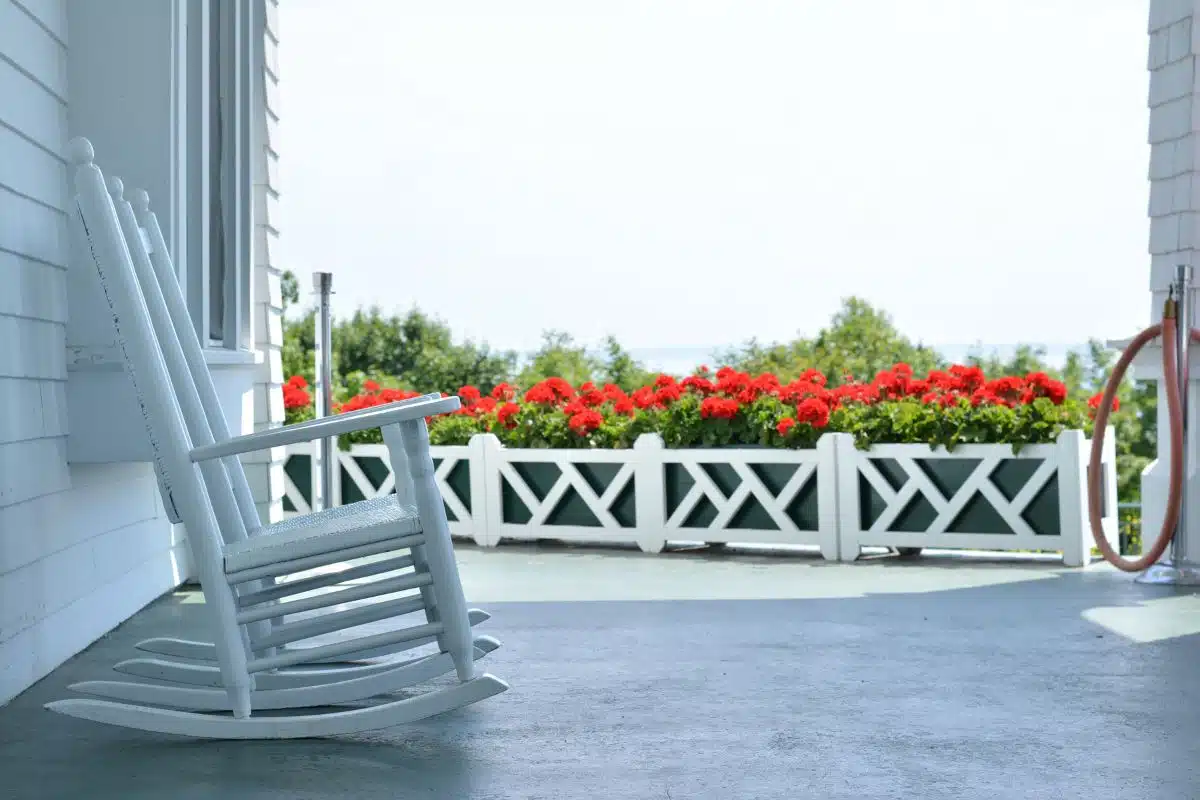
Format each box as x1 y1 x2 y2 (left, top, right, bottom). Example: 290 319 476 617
176 0 260 350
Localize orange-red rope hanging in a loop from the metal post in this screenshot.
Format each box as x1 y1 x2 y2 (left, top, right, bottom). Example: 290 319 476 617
1087 297 1200 572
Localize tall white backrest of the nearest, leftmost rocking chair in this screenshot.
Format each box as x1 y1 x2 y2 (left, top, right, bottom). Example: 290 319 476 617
68 139 223 584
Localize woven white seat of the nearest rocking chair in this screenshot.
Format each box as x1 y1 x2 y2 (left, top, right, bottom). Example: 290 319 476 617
224 495 421 573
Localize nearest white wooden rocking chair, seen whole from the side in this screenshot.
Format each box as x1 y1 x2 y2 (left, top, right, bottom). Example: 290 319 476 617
47 139 508 739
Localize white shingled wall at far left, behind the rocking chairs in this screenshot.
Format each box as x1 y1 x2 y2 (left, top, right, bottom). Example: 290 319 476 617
0 0 190 703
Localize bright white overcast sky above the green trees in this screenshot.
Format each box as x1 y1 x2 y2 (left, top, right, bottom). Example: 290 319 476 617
278 0 1151 362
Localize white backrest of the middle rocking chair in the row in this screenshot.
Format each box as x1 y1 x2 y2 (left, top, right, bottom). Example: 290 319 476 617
108 176 246 543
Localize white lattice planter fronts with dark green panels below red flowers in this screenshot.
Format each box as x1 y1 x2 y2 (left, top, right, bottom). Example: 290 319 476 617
276 431 1118 566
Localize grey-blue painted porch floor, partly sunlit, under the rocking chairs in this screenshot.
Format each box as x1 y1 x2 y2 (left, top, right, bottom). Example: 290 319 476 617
0 545 1200 800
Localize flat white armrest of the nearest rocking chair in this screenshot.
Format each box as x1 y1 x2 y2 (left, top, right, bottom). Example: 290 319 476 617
188 397 462 462
